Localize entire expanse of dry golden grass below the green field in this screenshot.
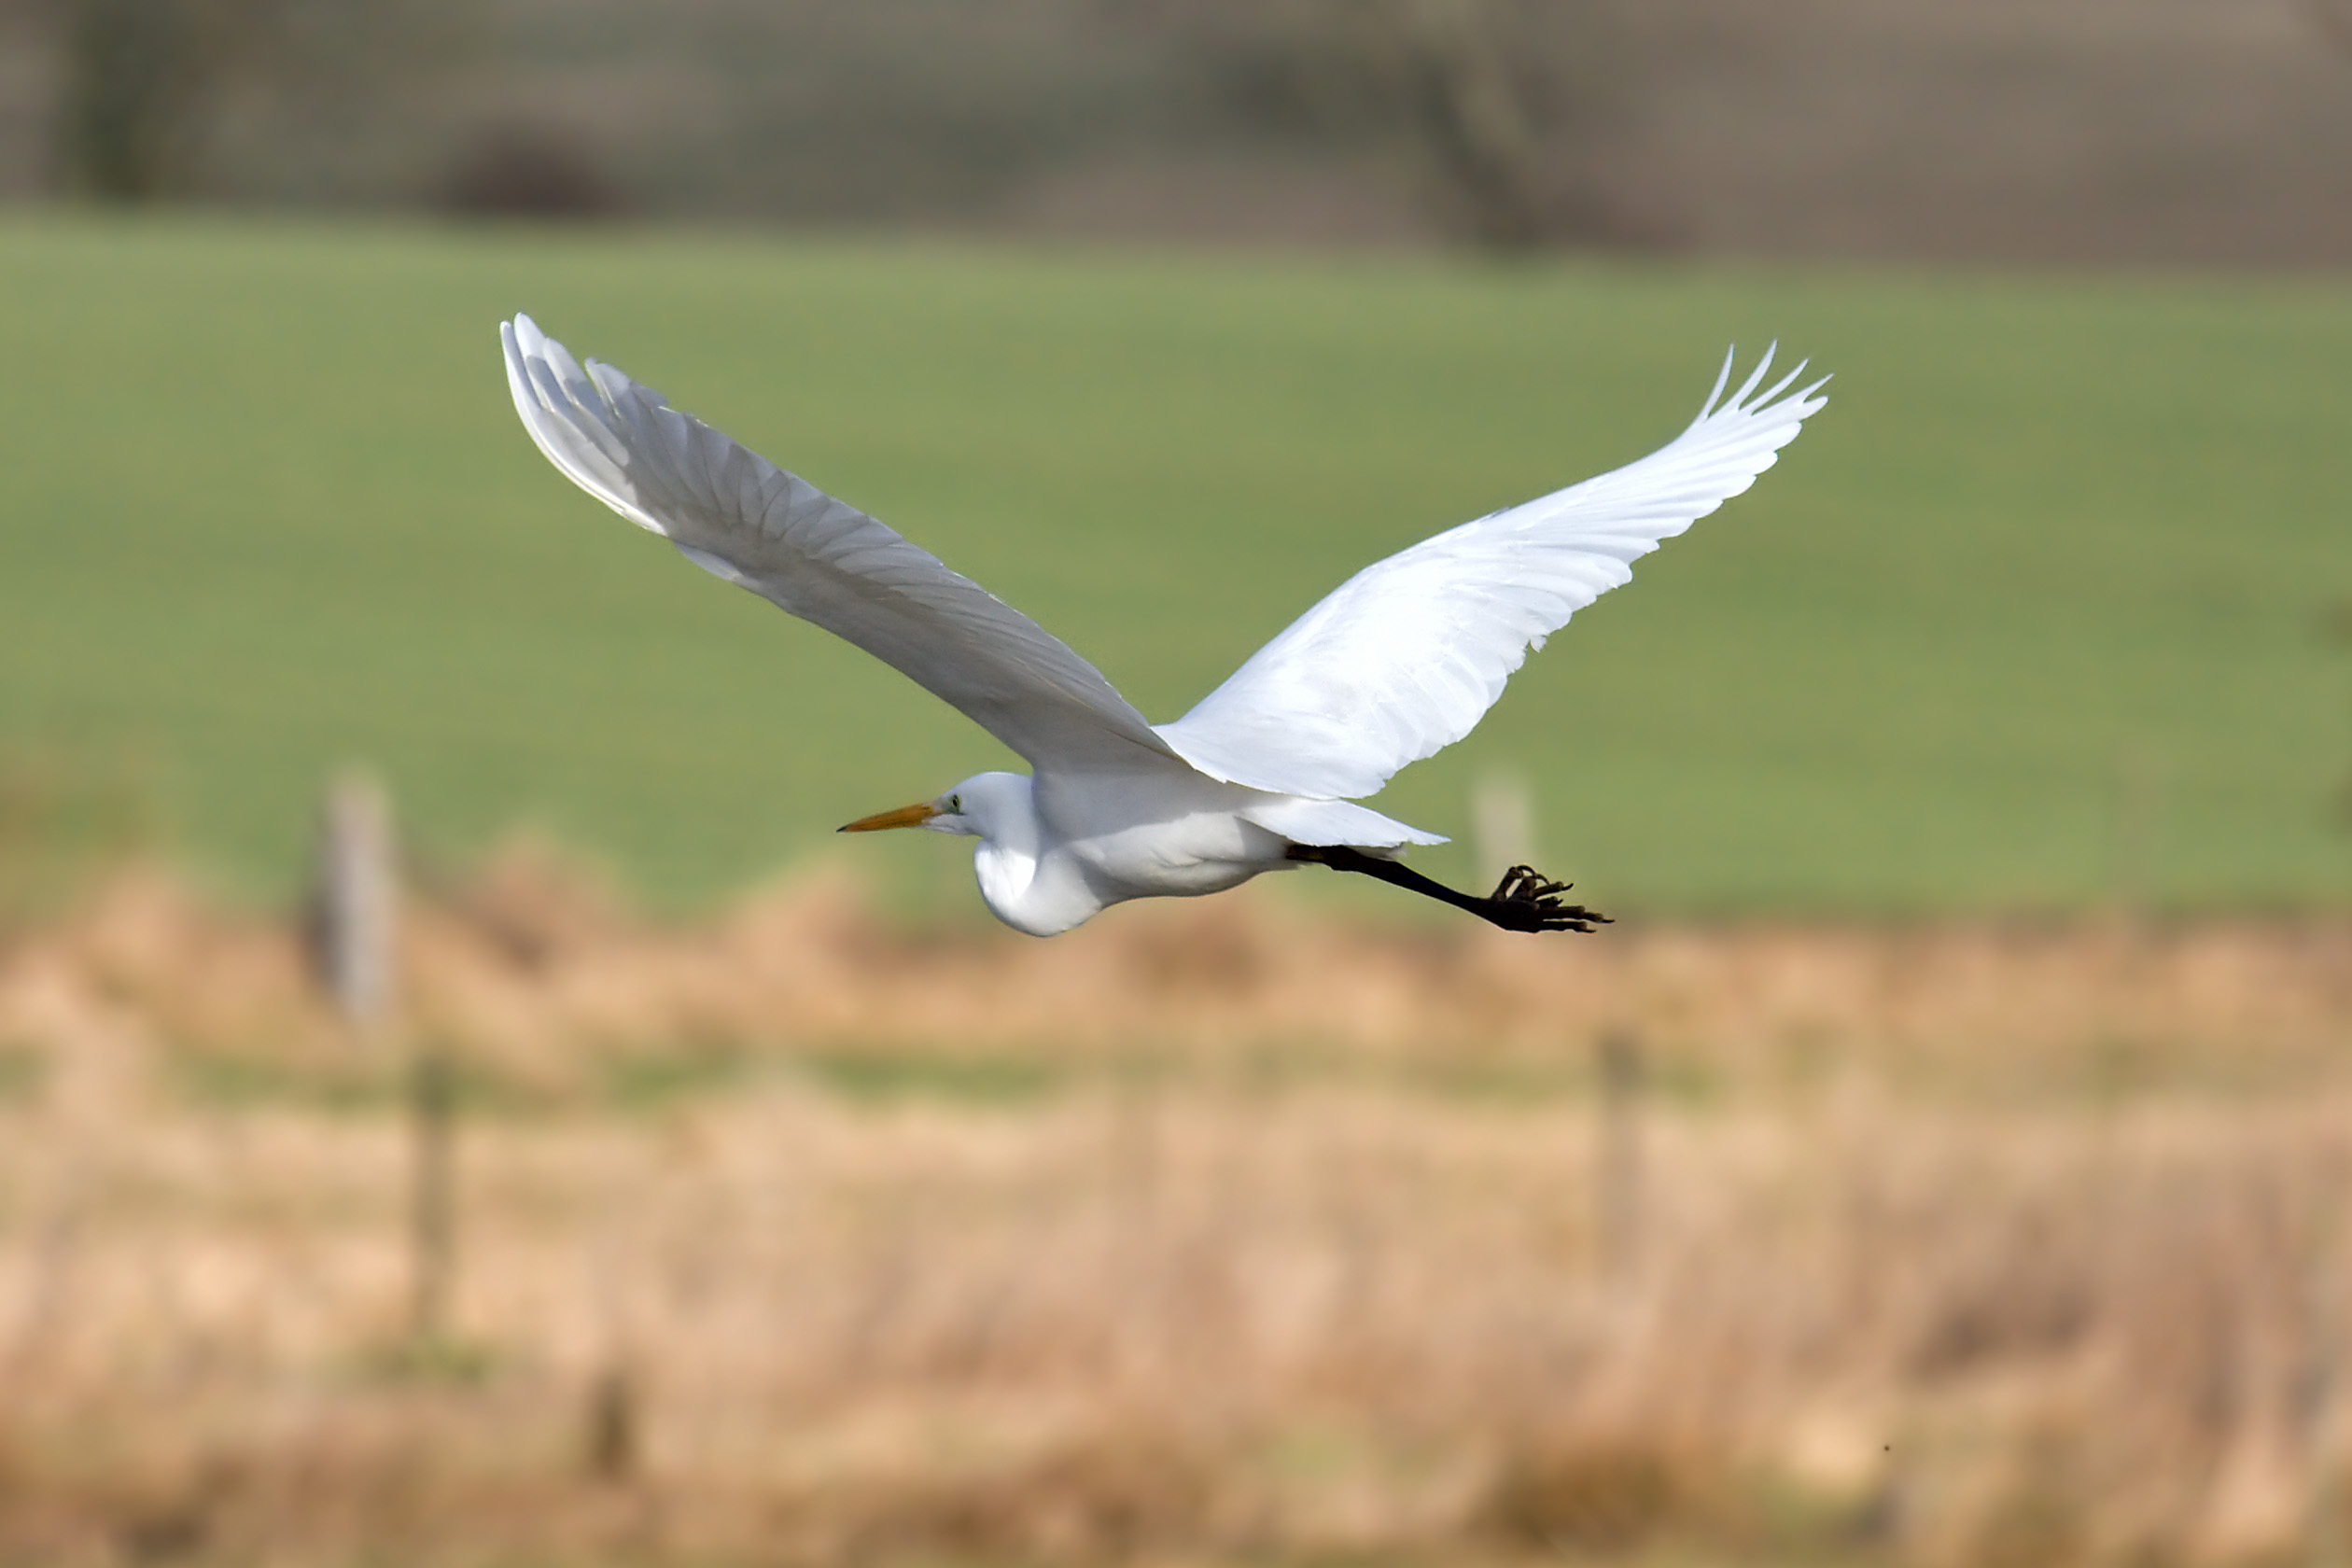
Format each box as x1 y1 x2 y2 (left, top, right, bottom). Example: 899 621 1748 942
0 858 2352 1568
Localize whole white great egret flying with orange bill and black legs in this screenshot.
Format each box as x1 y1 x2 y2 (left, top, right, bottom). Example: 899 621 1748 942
498 315 1823 935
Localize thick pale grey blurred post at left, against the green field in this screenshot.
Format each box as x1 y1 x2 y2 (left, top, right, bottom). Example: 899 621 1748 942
311 771 399 1037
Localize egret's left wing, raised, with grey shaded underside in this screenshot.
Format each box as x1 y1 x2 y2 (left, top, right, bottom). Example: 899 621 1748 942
498 315 1179 771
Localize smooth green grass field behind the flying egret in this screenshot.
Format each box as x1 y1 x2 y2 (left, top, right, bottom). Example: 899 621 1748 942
0 217 2352 912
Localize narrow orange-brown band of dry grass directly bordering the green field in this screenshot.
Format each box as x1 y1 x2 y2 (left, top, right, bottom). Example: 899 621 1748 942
22 848 2352 1093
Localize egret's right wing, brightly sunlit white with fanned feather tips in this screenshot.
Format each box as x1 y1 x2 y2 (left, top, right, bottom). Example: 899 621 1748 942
1159 353 1826 799
